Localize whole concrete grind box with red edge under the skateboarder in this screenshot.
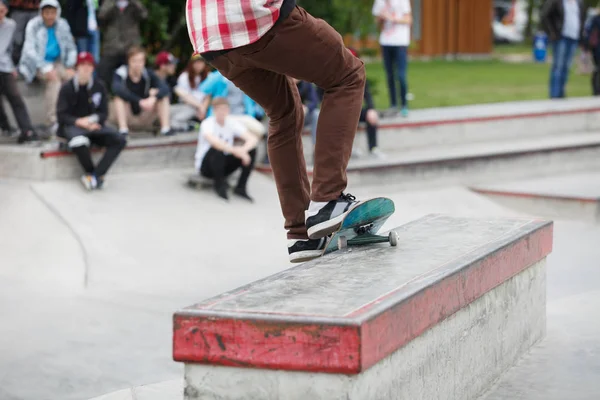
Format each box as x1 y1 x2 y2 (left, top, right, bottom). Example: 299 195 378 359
173 215 552 399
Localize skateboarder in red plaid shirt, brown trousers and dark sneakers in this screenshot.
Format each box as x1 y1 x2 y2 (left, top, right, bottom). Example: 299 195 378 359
186 0 366 262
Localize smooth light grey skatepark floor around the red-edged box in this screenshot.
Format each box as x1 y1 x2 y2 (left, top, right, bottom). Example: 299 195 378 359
0 167 600 400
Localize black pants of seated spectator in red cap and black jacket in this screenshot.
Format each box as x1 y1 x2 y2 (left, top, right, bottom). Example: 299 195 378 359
60 126 127 177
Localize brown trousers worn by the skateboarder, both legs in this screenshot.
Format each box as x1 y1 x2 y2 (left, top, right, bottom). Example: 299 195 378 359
211 7 365 239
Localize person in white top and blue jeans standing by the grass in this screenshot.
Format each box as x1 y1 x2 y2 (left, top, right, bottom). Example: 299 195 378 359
372 0 412 117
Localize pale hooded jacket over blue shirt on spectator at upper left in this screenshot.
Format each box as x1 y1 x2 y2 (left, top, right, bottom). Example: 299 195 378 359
19 0 77 82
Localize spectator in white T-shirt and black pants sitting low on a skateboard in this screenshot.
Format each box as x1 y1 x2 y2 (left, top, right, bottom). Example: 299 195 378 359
195 97 258 201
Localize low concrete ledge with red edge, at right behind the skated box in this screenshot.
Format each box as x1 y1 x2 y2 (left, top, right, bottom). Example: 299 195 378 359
472 172 600 223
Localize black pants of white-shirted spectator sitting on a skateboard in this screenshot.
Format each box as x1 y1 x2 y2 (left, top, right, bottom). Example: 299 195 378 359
200 148 256 189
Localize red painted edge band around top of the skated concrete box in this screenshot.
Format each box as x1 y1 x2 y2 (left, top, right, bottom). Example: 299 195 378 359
173 223 553 375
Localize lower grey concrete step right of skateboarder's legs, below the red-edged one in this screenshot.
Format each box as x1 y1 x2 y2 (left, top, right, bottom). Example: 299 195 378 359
258 133 600 186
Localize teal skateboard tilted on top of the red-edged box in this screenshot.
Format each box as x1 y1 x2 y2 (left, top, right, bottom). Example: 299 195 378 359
322 197 398 255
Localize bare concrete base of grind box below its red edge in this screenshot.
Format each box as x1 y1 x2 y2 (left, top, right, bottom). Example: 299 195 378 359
185 261 546 400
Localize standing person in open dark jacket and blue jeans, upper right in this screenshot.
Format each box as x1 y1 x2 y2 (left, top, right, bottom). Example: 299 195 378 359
540 0 587 98
